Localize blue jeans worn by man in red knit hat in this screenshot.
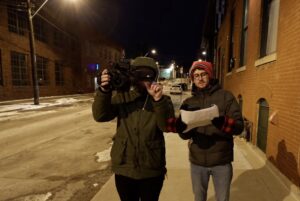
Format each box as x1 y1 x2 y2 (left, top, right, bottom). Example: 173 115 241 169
191 163 232 201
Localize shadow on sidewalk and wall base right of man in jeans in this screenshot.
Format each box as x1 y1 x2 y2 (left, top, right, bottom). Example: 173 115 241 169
208 140 300 201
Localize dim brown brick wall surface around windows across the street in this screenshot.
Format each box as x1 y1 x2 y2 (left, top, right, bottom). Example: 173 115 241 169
0 4 121 101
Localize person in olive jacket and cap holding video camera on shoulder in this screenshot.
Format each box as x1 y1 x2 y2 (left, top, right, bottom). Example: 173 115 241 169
92 57 174 201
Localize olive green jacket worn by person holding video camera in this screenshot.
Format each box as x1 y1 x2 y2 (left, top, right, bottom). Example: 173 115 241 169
92 90 174 179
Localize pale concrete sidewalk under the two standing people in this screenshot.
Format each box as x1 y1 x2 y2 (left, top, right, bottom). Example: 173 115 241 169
92 133 300 201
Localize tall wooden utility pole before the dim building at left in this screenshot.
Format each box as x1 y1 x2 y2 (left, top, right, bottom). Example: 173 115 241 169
27 0 40 105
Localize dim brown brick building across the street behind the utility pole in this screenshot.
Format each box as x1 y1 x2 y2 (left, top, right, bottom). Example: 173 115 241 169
0 0 122 101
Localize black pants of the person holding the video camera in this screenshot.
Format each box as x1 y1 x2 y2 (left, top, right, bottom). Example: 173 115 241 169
115 175 164 201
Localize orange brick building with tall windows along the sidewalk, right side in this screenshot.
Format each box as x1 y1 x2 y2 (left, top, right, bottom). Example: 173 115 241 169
201 0 300 188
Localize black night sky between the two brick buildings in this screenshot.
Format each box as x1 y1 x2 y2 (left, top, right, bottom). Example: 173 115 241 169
65 0 208 68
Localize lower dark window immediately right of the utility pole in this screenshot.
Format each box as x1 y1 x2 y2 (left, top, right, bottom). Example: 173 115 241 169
36 56 49 85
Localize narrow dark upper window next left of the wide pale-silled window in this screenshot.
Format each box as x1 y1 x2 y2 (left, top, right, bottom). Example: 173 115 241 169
240 0 249 66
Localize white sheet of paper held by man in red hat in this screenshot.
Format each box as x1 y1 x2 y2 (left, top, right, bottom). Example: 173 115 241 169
180 105 219 133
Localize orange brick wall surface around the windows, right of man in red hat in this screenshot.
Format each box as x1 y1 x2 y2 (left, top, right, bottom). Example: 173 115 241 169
217 0 300 186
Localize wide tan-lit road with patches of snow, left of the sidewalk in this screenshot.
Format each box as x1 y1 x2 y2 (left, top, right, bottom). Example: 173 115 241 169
0 92 190 201
